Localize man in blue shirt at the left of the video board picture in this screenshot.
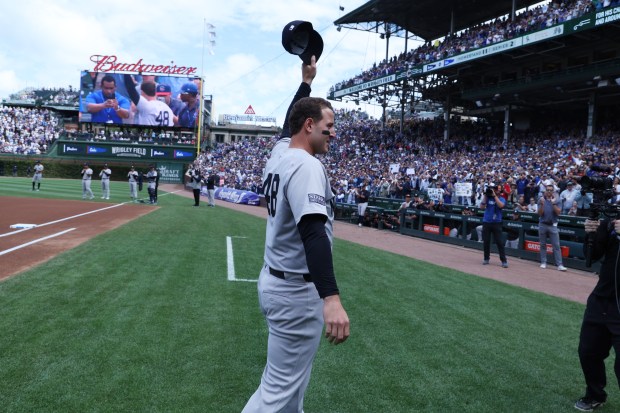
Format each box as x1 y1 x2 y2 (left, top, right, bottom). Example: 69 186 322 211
86 75 131 124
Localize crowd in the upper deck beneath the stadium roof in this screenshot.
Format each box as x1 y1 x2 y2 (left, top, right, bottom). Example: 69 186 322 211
331 0 608 92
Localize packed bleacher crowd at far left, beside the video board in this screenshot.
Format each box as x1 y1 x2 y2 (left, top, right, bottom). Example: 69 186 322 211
0 105 62 155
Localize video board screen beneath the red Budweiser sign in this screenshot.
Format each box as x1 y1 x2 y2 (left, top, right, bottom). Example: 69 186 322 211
80 70 202 129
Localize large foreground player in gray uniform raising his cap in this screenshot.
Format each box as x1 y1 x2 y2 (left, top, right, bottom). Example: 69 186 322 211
243 57 349 413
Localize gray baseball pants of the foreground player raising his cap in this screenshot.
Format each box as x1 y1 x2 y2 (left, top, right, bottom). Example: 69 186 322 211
242 266 323 413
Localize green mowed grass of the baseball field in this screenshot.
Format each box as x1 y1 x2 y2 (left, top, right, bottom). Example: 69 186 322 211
0 178 620 413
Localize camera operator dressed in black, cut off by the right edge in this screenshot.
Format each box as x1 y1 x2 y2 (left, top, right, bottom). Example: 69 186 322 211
575 218 620 412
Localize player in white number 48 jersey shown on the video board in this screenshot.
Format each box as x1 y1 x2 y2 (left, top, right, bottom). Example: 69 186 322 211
125 74 174 127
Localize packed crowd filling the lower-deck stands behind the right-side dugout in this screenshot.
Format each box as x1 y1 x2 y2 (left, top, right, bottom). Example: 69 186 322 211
198 110 620 211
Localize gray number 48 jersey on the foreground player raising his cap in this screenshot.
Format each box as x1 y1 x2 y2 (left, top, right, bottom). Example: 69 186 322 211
263 138 335 274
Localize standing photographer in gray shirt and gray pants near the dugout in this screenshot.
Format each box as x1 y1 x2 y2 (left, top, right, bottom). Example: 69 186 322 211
538 185 566 271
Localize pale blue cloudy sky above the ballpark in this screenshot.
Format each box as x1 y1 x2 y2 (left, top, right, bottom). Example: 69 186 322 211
0 0 412 125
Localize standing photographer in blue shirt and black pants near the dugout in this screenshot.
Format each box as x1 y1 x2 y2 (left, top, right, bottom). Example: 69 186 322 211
480 184 508 268
